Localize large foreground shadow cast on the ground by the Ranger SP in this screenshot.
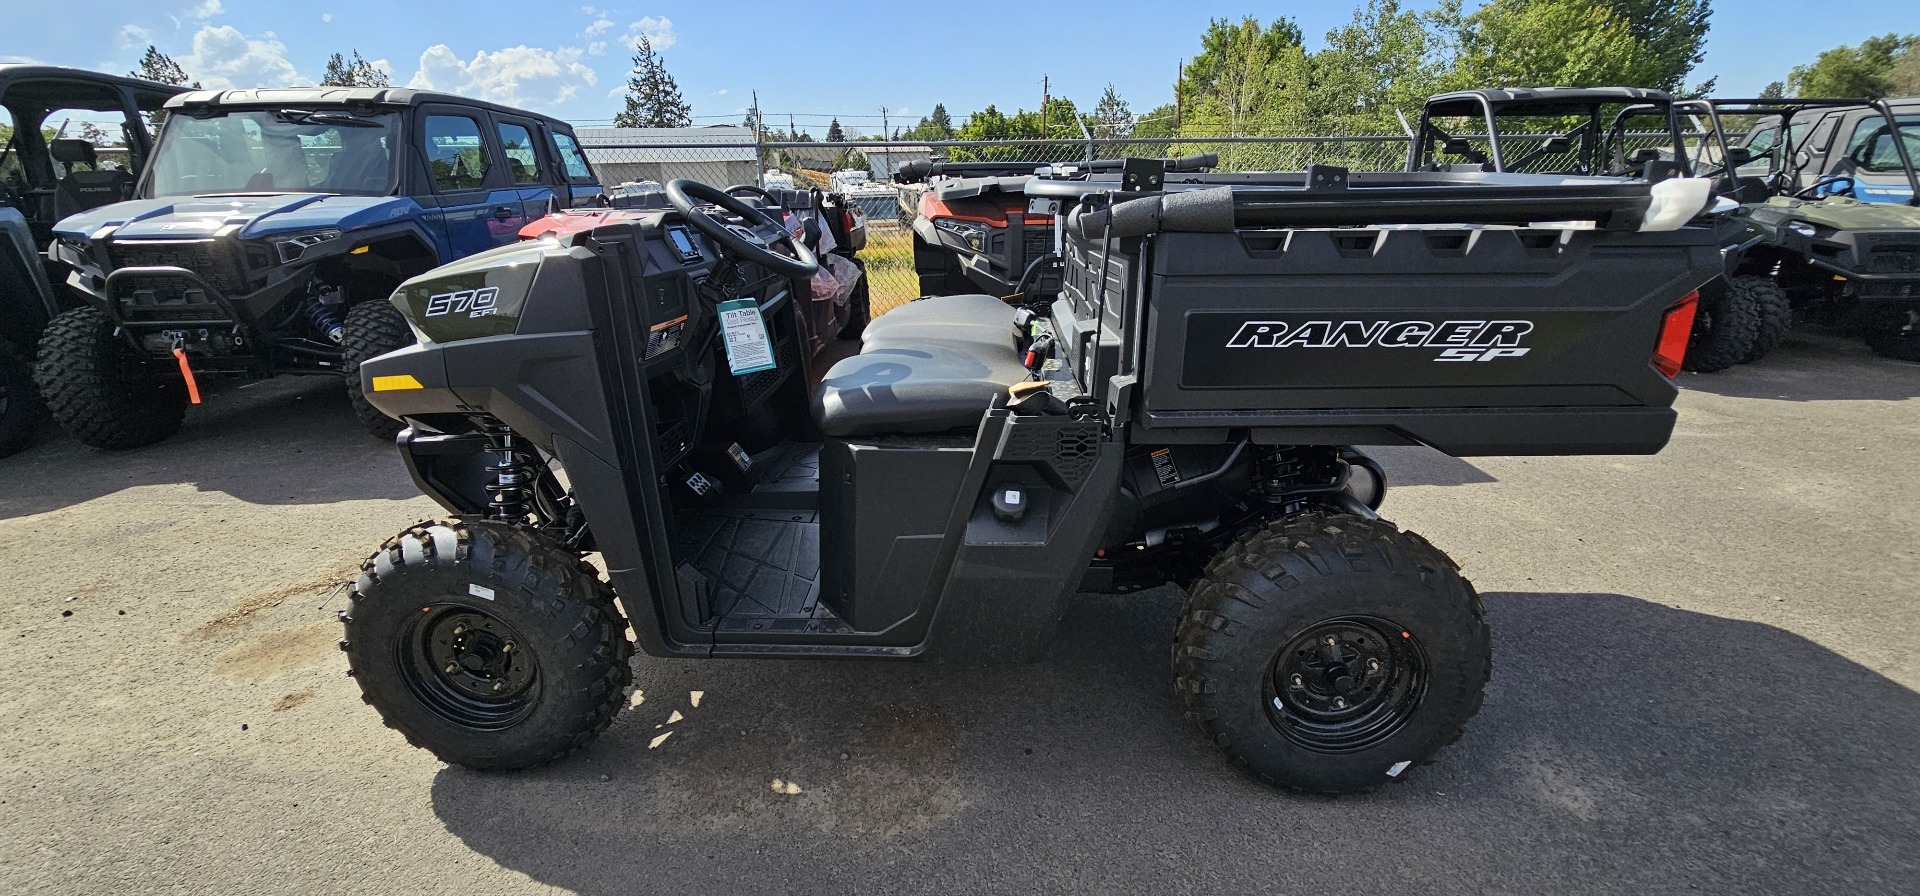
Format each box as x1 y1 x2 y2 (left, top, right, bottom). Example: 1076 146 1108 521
428 589 1920 894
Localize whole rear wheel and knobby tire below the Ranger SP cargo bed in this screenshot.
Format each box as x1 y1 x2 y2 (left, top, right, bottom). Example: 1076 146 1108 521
1173 512 1492 794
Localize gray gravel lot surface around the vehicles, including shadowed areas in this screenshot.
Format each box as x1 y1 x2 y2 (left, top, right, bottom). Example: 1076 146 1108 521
0 336 1920 894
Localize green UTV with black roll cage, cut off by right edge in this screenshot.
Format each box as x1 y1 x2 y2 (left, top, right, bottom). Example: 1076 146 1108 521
1715 98 1920 361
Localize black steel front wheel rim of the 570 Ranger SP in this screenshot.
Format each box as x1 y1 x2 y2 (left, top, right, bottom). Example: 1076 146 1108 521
396 602 540 731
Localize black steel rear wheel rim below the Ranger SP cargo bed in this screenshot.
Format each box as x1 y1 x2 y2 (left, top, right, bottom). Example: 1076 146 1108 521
1267 616 1428 752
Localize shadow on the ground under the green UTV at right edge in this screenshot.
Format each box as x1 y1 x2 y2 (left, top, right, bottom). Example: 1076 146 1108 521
1680 328 1920 401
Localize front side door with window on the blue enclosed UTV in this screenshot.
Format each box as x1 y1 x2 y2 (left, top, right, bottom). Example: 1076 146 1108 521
420 106 528 261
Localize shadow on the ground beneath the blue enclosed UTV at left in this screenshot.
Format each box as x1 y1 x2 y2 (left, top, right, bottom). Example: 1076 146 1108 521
0 376 419 520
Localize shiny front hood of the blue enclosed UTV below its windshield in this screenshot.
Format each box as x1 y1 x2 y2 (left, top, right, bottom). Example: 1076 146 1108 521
54 194 417 240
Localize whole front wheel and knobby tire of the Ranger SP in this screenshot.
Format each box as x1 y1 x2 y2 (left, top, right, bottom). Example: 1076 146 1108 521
340 522 634 769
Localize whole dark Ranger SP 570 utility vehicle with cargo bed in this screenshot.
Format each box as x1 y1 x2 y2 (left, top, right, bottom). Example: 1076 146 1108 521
342 163 1718 792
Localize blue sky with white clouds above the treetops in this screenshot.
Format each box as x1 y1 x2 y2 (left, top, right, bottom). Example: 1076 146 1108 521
0 0 1920 134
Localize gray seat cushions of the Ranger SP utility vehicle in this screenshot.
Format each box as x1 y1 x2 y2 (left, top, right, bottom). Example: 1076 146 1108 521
814 295 1027 437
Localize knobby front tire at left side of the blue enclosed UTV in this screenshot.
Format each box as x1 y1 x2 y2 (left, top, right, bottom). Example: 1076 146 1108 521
35 307 186 449
